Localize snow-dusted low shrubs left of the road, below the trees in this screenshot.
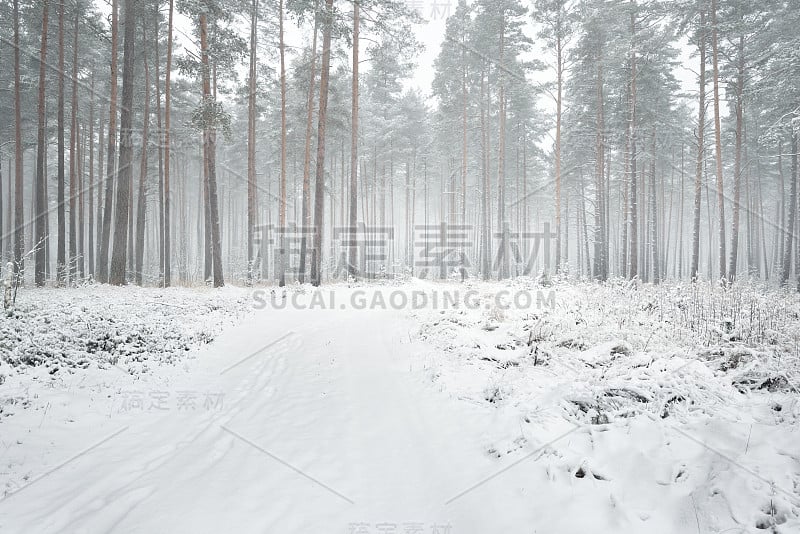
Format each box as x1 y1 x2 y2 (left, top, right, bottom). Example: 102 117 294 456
0 285 250 423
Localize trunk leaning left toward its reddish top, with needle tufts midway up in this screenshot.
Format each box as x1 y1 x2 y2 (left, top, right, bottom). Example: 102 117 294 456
200 13 225 287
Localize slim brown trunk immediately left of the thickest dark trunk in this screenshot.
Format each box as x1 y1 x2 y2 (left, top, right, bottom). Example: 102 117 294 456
97 0 119 283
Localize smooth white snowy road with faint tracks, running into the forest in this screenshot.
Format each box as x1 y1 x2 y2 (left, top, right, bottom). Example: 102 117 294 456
0 309 557 534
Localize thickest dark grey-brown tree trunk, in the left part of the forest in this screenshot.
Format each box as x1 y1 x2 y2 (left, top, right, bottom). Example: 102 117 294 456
108 0 137 286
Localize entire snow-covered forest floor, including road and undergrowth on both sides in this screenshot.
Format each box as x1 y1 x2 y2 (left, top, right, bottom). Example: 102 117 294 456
0 280 800 534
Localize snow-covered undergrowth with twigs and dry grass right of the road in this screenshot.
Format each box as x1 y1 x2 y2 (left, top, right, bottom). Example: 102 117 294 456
417 280 800 533
